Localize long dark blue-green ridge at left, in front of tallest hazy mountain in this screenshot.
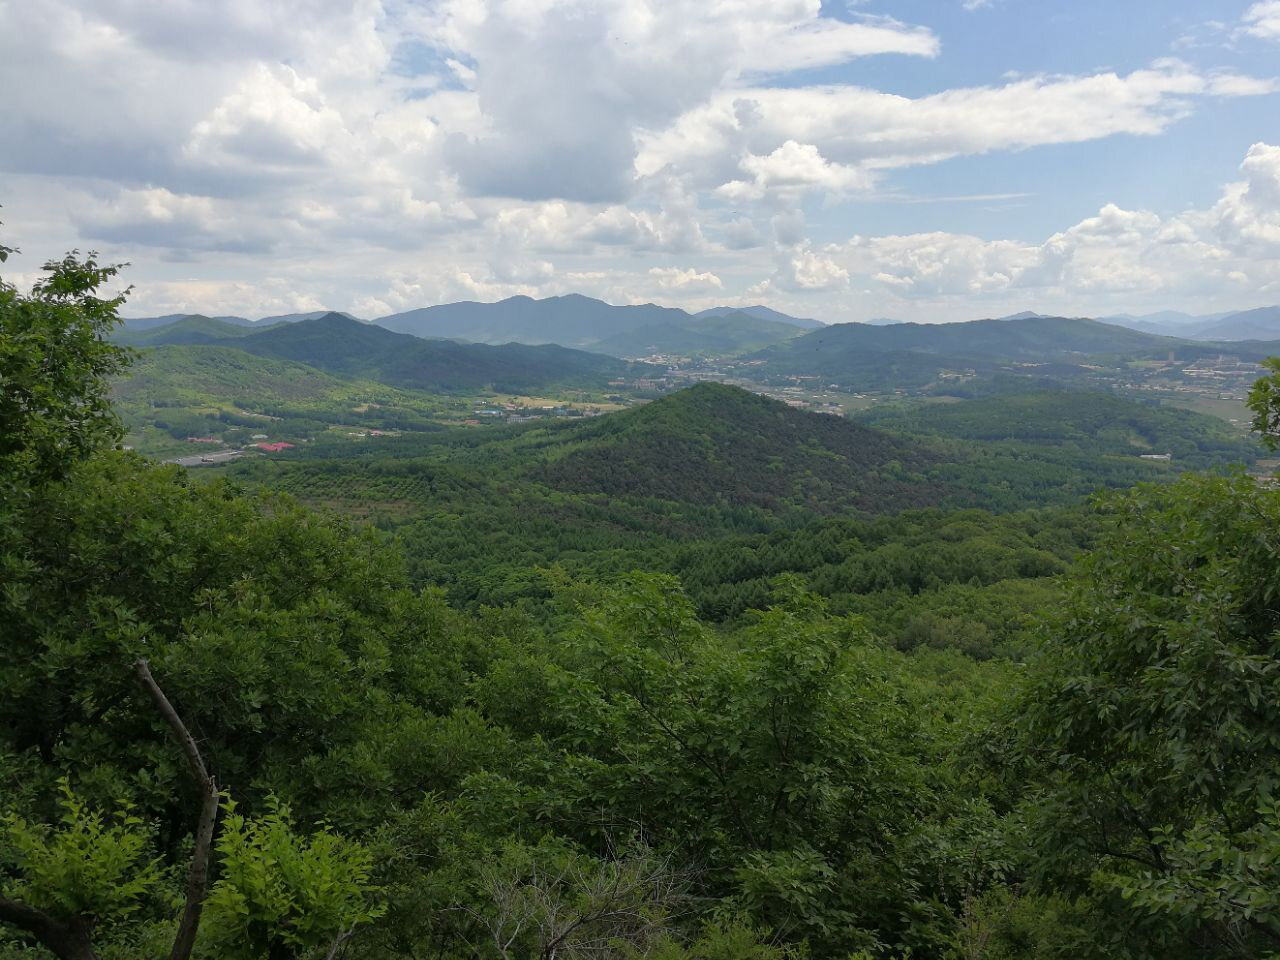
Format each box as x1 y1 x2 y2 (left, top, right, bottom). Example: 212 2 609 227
119 314 640 392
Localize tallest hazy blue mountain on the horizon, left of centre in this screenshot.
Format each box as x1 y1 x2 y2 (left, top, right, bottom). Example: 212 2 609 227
374 293 690 347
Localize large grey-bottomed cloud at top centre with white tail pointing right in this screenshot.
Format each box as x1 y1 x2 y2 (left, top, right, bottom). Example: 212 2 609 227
428 0 938 202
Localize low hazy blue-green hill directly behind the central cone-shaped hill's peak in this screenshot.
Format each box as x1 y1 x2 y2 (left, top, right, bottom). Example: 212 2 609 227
588 310 804 357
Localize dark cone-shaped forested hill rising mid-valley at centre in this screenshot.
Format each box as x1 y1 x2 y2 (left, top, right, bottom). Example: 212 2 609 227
531 384 937 511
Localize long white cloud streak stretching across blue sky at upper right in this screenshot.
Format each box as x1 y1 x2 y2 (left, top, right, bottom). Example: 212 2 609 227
636 60 1274 187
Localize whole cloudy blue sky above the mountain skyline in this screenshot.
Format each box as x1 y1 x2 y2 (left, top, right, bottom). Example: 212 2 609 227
0 0 1280 323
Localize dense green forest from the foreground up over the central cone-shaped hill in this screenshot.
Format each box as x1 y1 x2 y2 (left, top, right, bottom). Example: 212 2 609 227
0 255 1280 960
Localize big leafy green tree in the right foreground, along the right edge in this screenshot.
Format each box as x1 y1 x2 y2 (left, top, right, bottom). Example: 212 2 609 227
1021 476 1280 956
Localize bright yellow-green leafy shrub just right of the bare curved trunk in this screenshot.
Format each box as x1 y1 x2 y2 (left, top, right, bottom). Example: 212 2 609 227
206 797 383 960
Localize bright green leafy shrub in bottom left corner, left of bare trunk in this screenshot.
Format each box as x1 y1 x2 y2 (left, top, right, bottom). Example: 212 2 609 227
0 778 161 923
